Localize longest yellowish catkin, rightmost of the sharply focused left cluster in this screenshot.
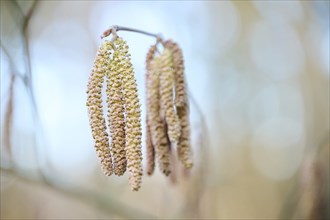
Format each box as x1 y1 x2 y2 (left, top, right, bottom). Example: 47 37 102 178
114 38 142 191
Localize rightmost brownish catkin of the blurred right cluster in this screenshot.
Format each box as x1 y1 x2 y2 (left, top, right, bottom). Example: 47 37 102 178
165 40 193 168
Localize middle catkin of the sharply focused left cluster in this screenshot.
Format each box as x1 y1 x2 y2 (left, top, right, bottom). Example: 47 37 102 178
106 41 126 176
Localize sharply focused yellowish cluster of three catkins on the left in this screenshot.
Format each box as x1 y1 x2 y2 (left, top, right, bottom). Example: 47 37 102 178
87 38 142 191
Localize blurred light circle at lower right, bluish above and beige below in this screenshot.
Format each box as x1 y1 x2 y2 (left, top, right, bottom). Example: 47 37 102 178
251 117 305 180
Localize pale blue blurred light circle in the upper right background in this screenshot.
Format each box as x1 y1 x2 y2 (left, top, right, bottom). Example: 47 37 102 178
250 20 305 81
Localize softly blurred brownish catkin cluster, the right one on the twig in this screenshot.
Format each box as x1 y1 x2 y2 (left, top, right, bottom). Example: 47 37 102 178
146 40 192 176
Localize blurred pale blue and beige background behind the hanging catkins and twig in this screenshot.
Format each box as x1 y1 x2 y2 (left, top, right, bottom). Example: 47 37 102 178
1 0 330 219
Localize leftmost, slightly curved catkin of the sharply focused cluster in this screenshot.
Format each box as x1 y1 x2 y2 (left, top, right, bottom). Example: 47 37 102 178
87 40 113 176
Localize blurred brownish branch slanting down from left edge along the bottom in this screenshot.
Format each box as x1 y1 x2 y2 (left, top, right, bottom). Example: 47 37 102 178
1 167 156 219
